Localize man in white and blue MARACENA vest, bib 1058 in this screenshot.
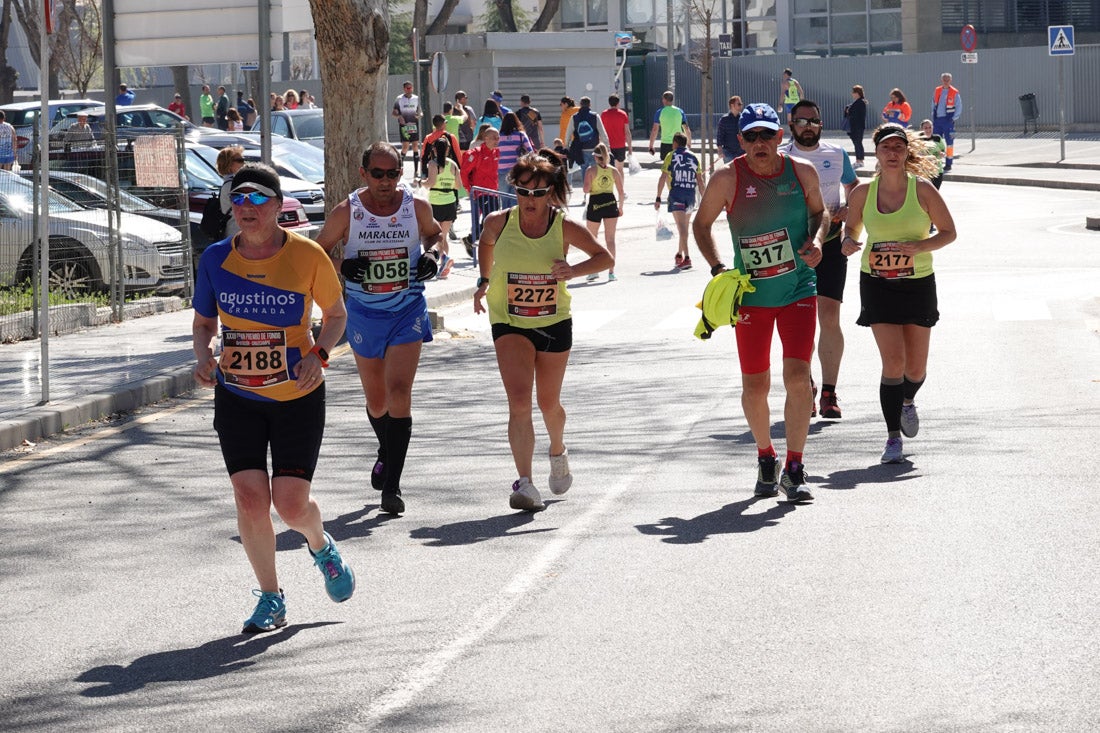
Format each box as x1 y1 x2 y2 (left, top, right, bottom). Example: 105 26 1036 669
317 142 443 514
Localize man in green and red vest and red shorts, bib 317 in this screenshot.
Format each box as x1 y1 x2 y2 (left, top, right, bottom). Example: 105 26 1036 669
694 103 828 502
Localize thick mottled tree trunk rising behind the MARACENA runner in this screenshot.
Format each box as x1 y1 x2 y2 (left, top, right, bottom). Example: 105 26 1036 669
310 0 389 211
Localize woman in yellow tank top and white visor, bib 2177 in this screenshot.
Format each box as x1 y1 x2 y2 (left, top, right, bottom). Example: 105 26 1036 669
840 123 955 463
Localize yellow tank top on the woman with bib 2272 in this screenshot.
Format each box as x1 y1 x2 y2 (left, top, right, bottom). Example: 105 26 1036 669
486 209 571 328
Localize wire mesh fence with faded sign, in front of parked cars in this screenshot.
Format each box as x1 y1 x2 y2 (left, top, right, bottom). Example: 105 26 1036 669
0 120 193 341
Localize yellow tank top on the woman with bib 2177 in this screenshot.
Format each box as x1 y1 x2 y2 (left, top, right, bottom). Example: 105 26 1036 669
859 175 932 280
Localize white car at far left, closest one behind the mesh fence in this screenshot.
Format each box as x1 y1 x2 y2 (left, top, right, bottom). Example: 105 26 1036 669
0 171 187 295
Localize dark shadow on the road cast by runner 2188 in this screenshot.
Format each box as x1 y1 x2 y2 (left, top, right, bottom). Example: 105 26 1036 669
75 621 339 698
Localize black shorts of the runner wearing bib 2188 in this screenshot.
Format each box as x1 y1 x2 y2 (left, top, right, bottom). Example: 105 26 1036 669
213 383 325 481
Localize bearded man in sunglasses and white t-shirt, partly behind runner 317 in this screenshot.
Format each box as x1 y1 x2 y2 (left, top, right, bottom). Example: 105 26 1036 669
779 99 857 419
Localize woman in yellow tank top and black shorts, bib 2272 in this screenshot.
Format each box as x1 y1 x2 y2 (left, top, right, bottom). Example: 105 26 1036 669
474 149 614 512
